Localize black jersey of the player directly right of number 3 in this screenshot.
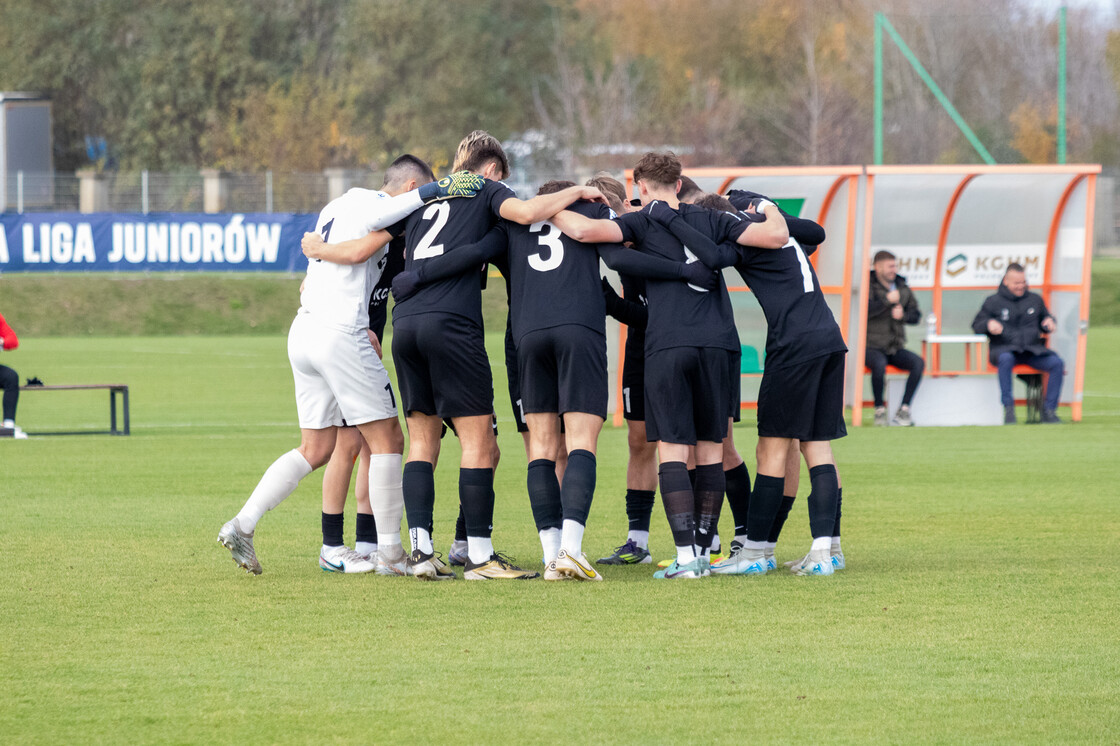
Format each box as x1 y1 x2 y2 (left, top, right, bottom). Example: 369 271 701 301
617 205 747 354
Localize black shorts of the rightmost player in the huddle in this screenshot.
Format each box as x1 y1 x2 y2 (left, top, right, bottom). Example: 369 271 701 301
758 352 848 441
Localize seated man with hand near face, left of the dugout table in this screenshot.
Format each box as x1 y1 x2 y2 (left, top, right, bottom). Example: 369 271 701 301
864 251 925 426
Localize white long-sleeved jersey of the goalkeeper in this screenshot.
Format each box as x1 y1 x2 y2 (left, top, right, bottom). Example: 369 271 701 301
299 188 422 333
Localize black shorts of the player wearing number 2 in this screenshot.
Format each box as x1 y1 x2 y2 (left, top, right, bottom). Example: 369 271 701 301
393 313 494 419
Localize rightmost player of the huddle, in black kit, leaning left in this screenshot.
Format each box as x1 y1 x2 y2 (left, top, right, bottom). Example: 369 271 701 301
654 189 847 576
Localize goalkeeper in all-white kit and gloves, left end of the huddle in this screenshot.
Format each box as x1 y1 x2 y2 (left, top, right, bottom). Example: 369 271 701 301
217 156 480 575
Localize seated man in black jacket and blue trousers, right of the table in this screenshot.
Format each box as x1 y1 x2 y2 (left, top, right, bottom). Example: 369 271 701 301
972 263 1065 425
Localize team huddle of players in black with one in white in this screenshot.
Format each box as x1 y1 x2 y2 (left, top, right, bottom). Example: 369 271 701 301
218 131 847 581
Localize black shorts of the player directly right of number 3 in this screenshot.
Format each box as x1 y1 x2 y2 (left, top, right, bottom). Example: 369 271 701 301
645 347 731 446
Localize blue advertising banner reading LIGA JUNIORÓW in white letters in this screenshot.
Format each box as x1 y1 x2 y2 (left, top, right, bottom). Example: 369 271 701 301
0 213 317 272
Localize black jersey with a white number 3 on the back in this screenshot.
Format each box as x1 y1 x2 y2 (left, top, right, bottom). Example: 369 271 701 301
506 202 612 344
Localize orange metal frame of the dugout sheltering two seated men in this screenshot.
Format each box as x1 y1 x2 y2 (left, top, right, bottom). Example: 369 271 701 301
851 165 1101 427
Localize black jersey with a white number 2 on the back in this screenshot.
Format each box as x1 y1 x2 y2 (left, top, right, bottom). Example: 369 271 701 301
389 181 517 325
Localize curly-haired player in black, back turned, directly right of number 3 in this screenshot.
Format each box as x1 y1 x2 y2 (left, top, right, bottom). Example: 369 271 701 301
553 152 788 579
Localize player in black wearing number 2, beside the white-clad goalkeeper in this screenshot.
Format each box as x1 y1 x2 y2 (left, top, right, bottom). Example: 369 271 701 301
304 141 601 580
